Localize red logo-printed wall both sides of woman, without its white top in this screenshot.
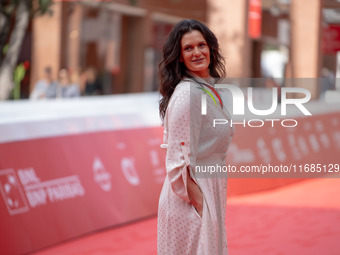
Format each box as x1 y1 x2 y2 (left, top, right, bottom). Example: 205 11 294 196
0 95 340 254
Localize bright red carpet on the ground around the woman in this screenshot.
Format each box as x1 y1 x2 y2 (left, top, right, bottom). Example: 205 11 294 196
33 179 340 255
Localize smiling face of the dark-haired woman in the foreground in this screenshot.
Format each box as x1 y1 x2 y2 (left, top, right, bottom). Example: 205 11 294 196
180 30 210 78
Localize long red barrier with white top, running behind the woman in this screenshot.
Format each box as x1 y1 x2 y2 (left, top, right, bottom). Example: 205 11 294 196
0 93 340 254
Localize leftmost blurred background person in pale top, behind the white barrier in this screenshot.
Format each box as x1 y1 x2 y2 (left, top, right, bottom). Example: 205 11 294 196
30 66 57 100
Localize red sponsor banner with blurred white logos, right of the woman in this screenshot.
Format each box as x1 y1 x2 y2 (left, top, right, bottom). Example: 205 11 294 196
227 112 340 178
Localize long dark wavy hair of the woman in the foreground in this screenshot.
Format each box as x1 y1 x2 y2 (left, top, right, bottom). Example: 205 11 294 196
159 19 226 120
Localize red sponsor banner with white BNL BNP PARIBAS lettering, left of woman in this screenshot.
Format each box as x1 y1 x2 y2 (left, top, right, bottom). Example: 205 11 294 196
0 127 165 254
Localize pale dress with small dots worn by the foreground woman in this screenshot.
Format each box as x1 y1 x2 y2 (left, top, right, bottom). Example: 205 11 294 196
157 77 234 255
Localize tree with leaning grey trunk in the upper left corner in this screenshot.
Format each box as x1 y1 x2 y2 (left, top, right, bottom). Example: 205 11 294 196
0 0 53 100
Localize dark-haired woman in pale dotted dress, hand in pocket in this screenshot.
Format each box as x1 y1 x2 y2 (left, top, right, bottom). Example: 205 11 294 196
157 20 233 255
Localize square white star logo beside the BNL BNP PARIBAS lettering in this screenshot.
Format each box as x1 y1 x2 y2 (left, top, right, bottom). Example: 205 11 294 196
0 169 29 215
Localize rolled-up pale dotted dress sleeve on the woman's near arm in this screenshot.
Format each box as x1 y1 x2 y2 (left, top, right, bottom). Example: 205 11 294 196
166 82 201 203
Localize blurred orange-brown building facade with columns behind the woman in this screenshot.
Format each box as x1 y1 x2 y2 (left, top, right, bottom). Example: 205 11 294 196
31 0 340 99
